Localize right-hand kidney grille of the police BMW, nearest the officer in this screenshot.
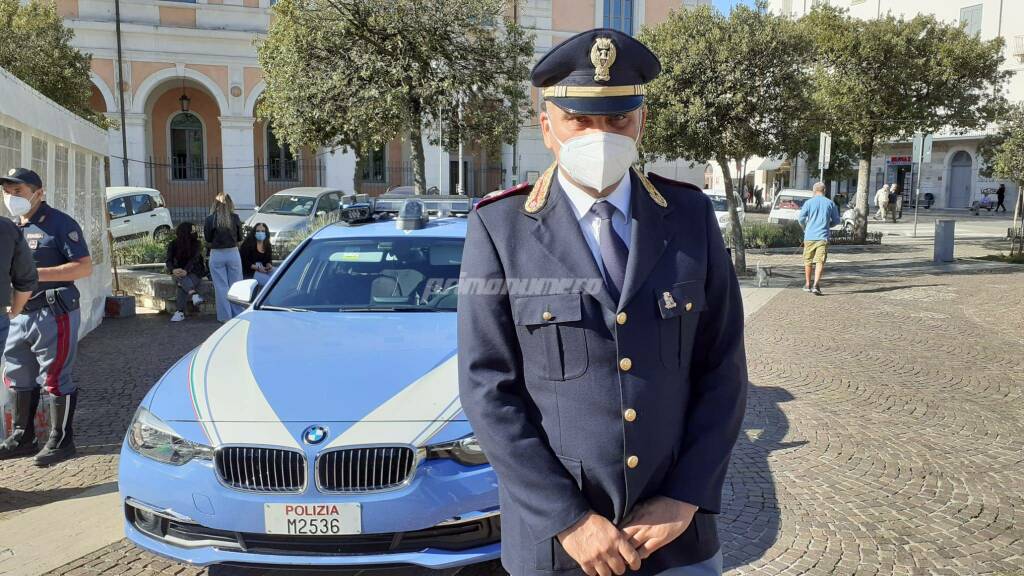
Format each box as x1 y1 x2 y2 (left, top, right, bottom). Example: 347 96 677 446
316 446 416 492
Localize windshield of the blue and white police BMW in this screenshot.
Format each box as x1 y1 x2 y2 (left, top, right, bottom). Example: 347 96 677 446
260 238 463 312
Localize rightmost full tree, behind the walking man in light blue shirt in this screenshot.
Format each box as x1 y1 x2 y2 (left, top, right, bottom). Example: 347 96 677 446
800 4 1010 240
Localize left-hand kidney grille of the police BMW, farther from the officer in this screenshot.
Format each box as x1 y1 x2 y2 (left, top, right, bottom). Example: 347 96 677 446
216 446 306 492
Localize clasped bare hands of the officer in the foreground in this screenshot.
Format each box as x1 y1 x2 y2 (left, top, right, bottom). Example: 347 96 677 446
558 496 697 576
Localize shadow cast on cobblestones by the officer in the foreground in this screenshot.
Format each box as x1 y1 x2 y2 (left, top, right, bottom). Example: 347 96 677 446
719 382 807 570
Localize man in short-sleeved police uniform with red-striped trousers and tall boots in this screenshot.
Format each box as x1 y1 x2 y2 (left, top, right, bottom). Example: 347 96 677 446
0 168 92 466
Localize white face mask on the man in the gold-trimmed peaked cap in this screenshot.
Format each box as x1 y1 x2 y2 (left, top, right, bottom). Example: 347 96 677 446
551 125 637 192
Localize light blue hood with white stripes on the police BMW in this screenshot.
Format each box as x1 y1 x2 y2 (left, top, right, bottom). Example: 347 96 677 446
148 311 461 446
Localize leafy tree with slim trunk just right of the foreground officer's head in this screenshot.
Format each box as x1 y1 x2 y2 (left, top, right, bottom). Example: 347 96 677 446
640 2 809 273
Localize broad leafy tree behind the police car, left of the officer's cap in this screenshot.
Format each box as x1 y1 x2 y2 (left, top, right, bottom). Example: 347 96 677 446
257 0 534 194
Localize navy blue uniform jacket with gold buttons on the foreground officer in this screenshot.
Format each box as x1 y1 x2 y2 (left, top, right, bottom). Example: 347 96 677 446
459 170 746 576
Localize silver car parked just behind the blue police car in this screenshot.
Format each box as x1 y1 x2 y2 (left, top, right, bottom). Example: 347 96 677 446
245 187 352 242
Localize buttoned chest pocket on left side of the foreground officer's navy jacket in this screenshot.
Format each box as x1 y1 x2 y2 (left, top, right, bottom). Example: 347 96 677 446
512 293 589 380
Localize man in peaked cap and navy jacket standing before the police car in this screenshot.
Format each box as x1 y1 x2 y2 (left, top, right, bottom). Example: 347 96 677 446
459 29 746 576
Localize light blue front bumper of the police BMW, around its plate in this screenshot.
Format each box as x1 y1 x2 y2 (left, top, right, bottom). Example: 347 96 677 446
119 438 501 569
